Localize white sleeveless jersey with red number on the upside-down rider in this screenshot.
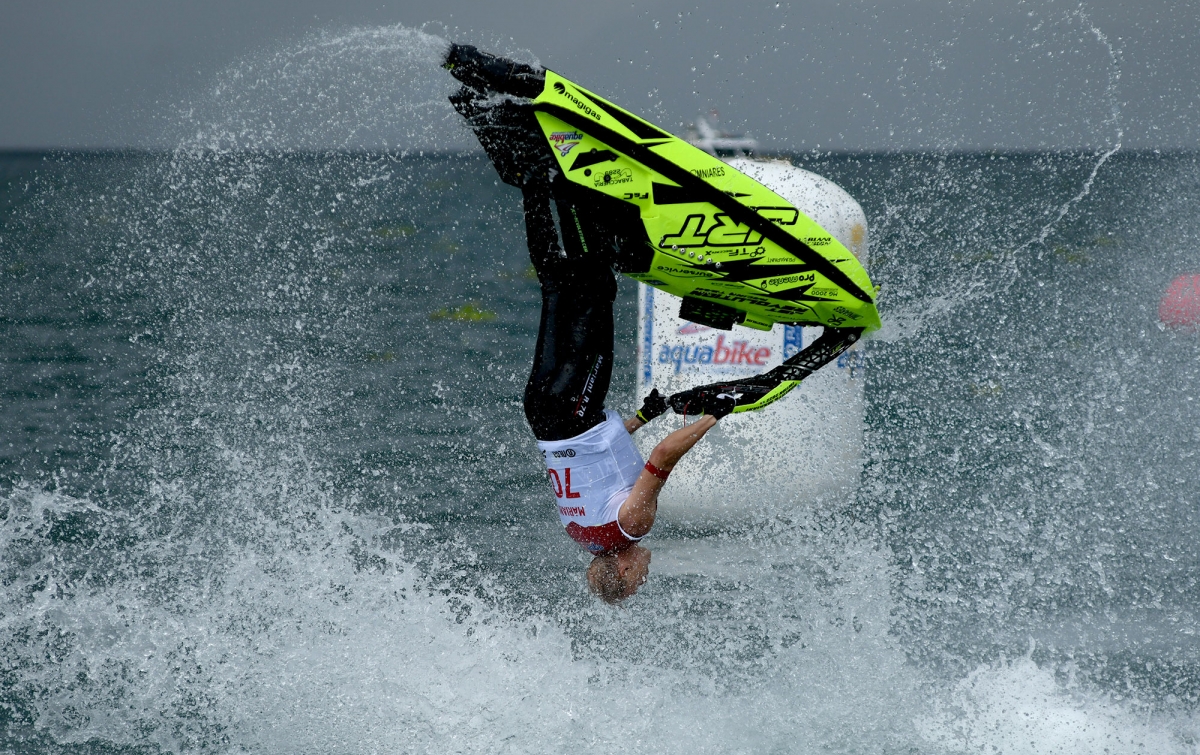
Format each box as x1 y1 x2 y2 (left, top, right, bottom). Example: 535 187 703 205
538 409 646 552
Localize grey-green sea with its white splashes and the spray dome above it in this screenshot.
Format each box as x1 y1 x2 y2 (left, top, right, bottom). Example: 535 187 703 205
0 23 1200 754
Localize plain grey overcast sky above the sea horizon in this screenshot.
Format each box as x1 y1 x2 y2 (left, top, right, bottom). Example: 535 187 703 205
0 0 1200 149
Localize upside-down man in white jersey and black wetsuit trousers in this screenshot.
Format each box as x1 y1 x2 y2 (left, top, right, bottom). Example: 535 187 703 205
524 179 733 601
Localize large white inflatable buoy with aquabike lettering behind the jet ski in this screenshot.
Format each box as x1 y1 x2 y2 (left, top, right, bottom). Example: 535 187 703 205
635 158 868 526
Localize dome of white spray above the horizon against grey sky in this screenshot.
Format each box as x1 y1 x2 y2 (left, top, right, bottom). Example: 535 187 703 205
178 26 458 151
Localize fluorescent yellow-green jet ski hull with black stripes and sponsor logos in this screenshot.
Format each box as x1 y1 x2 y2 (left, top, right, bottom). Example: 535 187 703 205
533 71 880 331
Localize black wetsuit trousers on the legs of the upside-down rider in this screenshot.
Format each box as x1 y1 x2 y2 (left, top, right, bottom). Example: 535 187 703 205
522 181 617 441
